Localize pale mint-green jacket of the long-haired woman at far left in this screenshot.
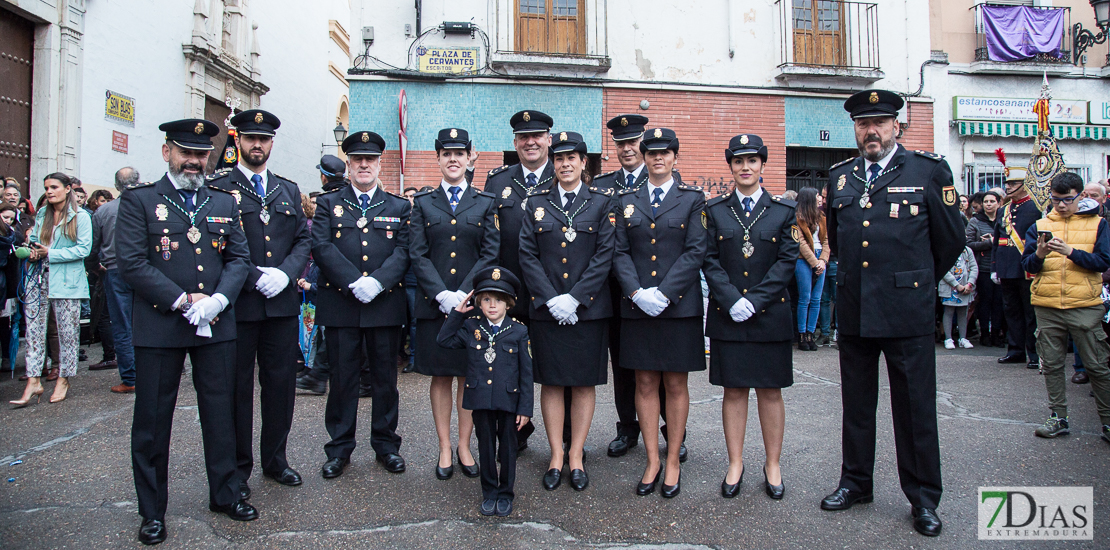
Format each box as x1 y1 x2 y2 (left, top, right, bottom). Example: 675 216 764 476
30 204 92 300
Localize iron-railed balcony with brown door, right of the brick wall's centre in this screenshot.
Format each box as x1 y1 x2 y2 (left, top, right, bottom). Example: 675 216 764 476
775 0 885 87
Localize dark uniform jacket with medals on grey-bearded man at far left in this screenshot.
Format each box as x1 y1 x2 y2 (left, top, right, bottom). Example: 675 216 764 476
115 176 250 348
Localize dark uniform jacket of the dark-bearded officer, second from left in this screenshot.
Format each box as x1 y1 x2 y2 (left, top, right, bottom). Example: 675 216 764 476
208 168 312 322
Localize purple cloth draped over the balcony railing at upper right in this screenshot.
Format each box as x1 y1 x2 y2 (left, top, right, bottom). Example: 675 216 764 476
982 6 1064 61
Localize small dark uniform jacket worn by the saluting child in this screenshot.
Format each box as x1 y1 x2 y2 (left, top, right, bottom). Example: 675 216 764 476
436 310 533 417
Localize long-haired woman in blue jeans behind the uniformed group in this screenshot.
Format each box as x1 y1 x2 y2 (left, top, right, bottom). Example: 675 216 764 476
794 187 829 351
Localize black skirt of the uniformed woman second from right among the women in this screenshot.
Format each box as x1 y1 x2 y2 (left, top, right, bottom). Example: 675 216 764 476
620 317 705 372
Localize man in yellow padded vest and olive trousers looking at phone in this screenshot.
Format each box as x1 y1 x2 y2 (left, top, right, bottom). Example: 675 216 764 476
1021 172 1110 443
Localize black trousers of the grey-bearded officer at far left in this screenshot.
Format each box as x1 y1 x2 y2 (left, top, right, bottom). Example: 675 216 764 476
131 341 240 520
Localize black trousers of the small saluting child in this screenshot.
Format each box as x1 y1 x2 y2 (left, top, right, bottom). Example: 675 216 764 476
471 409 516 500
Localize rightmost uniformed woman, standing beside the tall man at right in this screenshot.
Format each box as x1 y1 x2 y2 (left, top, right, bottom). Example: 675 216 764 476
703 134 801 499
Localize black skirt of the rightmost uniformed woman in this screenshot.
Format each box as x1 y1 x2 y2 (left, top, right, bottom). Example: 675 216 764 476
709 339 794 388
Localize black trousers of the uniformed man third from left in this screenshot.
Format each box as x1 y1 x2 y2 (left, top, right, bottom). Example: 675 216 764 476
324 327 401 459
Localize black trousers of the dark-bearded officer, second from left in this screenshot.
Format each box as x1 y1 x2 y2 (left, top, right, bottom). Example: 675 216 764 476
235 317 302 480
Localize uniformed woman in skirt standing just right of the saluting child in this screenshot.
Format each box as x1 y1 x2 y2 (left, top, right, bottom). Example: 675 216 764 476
521 132 616 491
